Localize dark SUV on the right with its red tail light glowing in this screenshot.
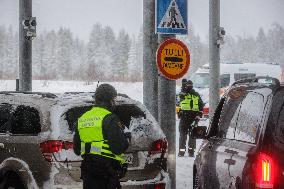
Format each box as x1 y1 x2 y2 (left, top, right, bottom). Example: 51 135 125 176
193 77 284 189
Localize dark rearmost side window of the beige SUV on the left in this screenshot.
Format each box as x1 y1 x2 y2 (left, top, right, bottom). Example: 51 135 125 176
11 105 41 135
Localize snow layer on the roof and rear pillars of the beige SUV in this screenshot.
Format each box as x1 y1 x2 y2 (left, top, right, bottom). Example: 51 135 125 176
0 92 165 140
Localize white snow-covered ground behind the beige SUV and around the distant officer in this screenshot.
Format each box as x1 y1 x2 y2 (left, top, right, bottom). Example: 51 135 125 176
0 80 204 189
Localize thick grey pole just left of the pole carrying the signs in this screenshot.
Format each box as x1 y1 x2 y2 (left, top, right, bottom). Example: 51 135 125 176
143 0 158 120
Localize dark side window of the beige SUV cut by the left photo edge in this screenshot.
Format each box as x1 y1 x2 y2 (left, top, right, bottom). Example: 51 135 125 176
0 104 14 133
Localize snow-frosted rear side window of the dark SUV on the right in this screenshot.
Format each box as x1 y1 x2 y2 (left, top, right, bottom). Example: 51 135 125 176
235 92 265 143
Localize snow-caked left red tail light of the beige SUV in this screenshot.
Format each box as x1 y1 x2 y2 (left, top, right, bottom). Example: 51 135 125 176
40 140 81 162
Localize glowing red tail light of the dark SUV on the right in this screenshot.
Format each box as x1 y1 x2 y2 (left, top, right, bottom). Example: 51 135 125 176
255 153 276 189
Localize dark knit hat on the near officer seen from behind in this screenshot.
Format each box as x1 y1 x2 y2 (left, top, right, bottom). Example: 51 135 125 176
93 83 117 102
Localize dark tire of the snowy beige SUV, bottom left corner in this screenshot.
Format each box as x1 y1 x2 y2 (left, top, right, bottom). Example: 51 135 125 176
0 172 25 189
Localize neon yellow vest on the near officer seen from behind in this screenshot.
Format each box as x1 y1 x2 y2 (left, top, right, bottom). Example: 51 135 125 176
78 107 125 163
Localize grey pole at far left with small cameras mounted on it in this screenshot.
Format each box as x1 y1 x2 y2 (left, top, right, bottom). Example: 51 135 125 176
19 0 32 91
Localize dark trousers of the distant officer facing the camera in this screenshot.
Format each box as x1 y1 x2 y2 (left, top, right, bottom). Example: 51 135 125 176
179 116 196 149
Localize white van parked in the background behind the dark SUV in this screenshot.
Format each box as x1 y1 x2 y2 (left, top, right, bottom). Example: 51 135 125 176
190 62 281 118
